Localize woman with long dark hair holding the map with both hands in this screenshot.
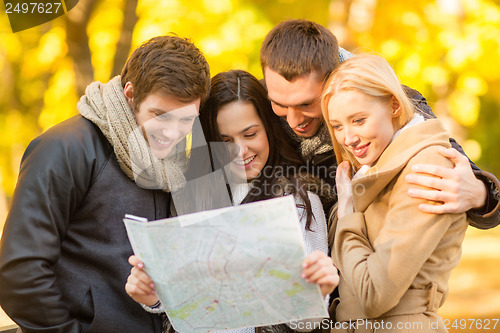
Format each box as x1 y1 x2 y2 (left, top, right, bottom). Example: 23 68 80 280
126 70 339 332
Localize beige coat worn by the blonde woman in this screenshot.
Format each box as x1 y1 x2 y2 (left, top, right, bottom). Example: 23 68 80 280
331 120 468 333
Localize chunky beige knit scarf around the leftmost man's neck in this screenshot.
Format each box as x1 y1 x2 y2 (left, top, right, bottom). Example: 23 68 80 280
77 76 187 192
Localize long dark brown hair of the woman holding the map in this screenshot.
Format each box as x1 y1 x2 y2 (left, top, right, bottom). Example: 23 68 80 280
200 70 312 229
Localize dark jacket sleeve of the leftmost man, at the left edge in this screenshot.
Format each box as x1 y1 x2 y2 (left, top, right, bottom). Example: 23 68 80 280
0 120 103 332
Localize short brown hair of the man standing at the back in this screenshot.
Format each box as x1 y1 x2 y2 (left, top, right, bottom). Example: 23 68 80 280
260 20 339 81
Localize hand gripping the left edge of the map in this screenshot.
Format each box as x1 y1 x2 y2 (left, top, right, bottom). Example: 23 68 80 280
125 256 158 306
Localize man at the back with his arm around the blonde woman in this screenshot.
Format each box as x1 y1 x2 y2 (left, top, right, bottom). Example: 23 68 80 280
260 20 500 229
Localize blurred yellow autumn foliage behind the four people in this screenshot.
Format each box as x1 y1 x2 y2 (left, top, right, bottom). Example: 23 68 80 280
0 0 500 329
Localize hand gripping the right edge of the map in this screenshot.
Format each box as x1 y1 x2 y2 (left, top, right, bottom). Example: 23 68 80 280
302 250 340 297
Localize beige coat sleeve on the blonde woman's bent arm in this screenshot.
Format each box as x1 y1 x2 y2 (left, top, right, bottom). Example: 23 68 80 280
333 151 466 318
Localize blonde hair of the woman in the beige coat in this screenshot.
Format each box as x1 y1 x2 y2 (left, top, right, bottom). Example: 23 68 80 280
321 54 415 170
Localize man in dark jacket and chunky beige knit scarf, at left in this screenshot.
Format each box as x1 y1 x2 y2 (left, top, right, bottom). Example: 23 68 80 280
0 36 210 333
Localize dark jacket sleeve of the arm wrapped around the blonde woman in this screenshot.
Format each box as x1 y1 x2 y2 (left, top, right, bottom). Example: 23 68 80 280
403 86 500 229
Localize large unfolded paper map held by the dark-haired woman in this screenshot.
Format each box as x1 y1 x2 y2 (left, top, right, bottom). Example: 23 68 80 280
124 196 328 332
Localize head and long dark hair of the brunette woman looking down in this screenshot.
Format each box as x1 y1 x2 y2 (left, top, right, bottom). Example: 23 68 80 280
200 70 319 229
